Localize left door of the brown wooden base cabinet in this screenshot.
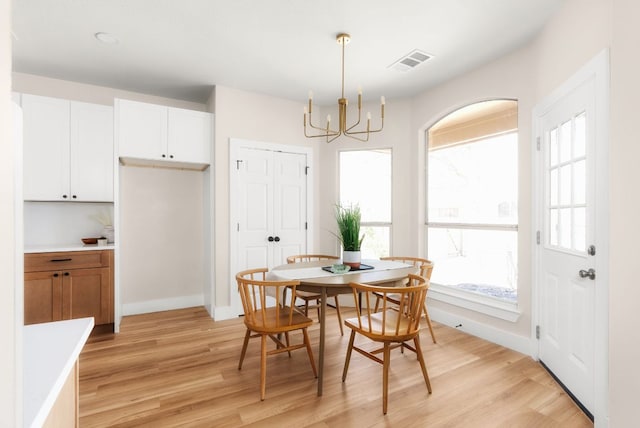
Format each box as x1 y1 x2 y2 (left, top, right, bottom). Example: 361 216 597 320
24 271 62 325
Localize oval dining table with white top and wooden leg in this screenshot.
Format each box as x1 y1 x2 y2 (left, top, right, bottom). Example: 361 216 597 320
269 260 419 396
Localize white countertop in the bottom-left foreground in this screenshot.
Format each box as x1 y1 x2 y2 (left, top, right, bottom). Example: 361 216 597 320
23 318 93 427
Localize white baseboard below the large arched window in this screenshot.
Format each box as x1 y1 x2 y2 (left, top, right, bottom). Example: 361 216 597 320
429 308 536 358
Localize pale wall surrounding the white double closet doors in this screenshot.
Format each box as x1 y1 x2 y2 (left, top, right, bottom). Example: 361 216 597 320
212 86 321 309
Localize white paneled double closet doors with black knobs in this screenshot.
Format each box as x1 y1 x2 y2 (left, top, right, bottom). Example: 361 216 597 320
230 147 308 313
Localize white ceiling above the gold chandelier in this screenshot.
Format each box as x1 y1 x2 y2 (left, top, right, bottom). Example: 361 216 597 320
12 0 563 105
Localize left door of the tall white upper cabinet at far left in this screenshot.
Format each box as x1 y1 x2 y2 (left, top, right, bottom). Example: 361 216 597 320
22 94 70 201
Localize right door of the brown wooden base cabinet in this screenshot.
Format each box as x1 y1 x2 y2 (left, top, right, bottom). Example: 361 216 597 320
62 268 111 325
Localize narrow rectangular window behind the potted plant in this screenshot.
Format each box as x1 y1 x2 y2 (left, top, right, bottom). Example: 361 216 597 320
340 149 391 259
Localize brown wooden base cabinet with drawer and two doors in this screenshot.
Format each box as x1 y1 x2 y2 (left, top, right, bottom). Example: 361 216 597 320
24 250 113 325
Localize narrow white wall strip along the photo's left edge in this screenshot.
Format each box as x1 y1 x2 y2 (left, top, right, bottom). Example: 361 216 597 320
0 0 22 427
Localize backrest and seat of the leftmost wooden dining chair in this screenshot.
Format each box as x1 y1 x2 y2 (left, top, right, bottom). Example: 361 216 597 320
236 268 300 332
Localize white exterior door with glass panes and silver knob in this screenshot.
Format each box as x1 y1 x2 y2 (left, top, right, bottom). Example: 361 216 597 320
536 50 607 413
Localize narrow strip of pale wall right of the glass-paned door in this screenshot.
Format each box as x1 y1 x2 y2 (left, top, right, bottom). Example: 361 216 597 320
609 0 640 427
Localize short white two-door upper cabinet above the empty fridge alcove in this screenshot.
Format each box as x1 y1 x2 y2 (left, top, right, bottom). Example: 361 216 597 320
115 100 212 169
